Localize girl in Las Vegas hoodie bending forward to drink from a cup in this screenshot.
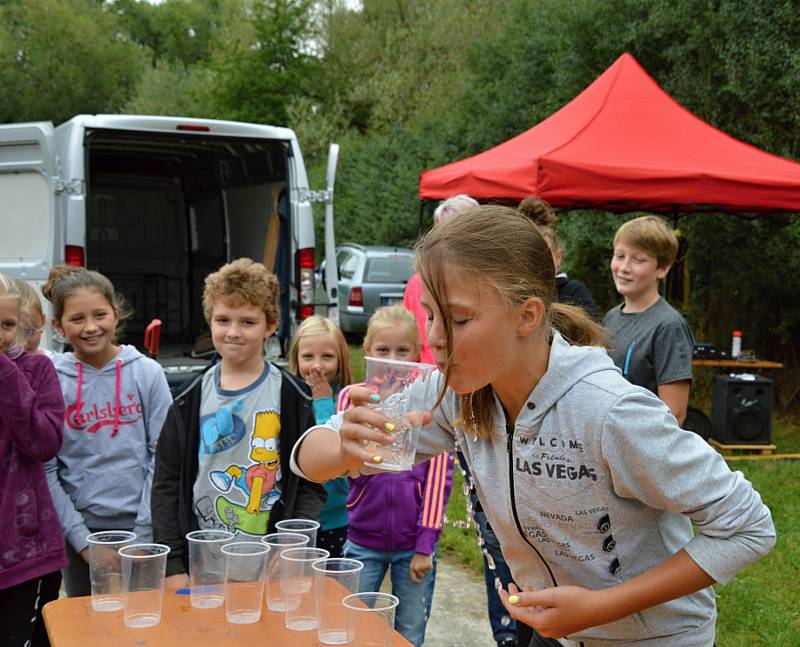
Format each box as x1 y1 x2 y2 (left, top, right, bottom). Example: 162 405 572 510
293 206 775 647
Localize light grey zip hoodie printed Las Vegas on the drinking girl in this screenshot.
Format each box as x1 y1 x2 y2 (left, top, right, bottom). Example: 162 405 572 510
293 332 775 647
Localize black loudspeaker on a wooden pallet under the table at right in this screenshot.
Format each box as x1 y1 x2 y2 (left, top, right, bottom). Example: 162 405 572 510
711 374 772 445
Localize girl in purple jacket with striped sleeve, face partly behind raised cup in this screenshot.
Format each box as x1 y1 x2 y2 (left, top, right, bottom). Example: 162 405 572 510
337 305 453 647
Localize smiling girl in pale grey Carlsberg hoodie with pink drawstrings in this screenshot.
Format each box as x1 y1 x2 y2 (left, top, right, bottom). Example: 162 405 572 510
42 266 172 596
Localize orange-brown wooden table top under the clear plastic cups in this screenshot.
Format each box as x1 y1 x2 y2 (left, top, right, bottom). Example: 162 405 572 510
43 589 411 647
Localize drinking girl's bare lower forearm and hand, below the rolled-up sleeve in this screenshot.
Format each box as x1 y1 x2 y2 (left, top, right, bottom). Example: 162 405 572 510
500 550 714 638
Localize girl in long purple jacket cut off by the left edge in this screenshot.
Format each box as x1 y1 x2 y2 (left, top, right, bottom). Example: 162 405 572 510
0 274 66 646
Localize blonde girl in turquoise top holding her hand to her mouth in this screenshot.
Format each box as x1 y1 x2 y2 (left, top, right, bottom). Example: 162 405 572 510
289 315 351 557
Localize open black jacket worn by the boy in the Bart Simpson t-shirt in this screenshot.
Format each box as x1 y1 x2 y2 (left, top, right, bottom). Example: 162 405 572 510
150 366 328 576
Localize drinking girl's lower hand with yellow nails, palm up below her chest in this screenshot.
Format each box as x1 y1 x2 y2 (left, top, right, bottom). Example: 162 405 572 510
498 583 617 638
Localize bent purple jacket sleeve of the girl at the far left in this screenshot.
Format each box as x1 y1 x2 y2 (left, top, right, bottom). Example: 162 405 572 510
0 353 64 462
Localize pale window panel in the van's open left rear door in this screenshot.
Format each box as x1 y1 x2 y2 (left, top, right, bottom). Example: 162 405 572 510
0 171 50 260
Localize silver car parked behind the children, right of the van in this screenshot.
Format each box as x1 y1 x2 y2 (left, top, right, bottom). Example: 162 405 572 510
336 243 414 333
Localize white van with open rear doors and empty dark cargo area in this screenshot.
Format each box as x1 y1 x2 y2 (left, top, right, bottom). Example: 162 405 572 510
0 115 333 383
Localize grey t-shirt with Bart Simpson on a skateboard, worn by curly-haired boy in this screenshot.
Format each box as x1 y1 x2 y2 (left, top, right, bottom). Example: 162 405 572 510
194 360 281 538
